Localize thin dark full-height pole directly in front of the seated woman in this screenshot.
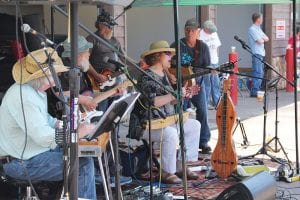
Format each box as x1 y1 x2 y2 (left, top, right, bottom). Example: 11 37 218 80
173 0 187 200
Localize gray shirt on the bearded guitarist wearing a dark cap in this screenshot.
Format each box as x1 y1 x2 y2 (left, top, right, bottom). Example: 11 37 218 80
86 31 124 72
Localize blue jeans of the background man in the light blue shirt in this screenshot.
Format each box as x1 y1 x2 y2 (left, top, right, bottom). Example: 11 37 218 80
250 54 264 96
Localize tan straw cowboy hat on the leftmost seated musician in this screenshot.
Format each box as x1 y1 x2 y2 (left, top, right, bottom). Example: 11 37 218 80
12 48 69 84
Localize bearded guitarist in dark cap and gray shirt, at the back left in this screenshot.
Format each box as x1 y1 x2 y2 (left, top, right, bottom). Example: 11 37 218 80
86 10 125 111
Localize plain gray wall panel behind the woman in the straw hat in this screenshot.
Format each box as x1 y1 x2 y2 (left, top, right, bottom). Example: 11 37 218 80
126 7 197 61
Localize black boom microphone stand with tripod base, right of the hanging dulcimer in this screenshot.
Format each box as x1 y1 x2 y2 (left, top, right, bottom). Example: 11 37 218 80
240 43 294 164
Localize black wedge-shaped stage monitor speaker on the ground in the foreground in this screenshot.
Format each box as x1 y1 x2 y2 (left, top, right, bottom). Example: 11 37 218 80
217 171 276 200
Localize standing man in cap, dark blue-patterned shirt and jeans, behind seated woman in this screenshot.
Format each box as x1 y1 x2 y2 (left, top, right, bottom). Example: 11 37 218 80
168 18 211 154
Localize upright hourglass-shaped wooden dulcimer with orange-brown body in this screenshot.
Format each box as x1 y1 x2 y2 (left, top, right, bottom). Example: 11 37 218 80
211 80 238 178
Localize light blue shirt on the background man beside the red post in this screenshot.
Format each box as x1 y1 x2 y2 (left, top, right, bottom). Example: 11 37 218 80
248 24 266 56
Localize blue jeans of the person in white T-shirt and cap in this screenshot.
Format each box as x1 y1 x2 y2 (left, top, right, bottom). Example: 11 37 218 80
203 71 220 107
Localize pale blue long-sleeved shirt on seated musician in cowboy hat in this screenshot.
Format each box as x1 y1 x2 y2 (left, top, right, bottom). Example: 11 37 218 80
0 83 57 160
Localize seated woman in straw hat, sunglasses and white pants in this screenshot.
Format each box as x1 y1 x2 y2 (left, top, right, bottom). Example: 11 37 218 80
129 41 200 184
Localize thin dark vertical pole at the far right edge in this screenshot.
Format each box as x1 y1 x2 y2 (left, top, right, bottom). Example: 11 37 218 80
293 0 299 174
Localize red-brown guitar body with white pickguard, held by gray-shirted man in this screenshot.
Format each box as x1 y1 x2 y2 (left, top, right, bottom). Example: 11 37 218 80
88 69 123 91
